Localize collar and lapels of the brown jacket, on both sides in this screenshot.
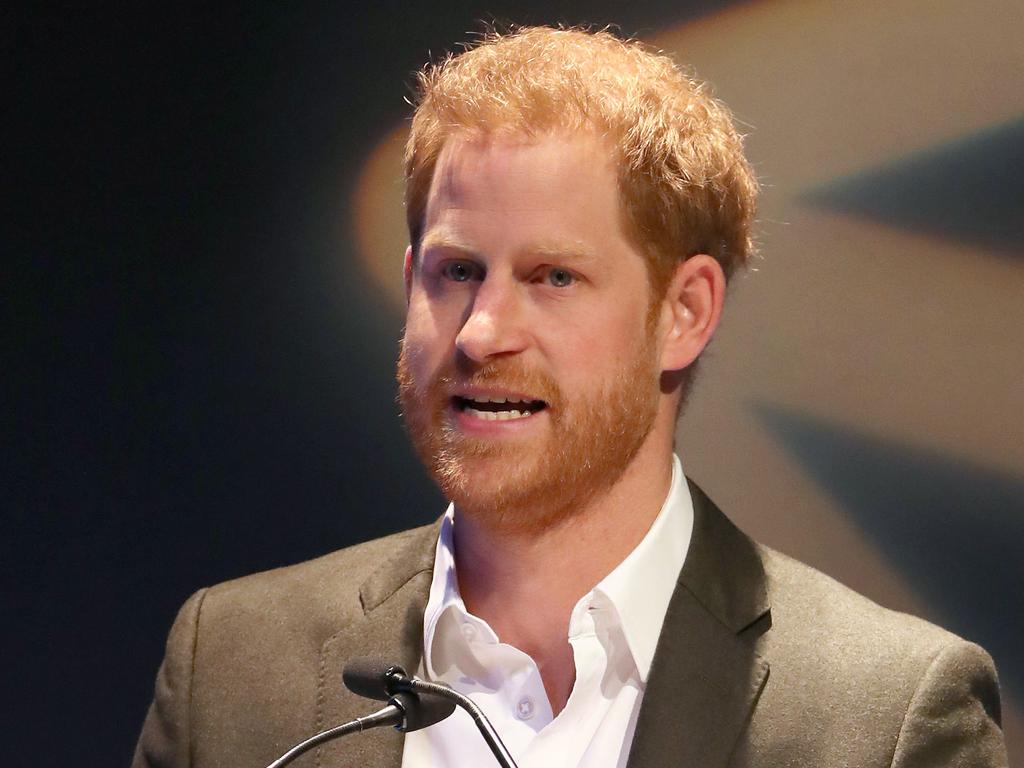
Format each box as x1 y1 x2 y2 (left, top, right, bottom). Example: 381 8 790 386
316 482 771 768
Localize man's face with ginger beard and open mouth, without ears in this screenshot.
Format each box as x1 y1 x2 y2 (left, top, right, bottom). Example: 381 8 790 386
398 133 659 530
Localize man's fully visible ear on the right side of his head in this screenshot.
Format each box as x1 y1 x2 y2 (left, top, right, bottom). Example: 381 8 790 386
660 254 725 371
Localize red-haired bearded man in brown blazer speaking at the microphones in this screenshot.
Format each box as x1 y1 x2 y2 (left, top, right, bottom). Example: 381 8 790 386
135 29 1007 768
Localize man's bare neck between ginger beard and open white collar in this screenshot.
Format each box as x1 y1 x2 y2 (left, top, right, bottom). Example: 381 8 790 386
455 423 672 713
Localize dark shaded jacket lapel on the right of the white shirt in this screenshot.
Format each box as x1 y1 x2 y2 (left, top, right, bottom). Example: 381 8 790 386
629 483 771 768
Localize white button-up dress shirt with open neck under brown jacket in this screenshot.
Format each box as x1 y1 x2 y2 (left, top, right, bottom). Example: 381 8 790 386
401 456 693 768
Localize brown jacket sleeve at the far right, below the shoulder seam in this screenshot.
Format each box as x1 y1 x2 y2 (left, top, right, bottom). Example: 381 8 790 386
892 640 1009 768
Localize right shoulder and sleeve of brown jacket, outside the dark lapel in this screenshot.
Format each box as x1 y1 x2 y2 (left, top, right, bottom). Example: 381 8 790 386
745 545 1006 765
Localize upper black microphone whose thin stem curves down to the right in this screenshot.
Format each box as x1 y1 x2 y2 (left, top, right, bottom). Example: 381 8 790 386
341 656 518 768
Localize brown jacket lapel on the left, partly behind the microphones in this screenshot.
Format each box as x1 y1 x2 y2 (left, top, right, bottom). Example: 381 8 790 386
315 525 438 768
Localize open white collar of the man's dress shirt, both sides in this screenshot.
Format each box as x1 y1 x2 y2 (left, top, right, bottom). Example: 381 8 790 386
423 455 693 683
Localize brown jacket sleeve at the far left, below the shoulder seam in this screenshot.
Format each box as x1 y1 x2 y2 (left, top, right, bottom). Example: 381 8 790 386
131 590 206 768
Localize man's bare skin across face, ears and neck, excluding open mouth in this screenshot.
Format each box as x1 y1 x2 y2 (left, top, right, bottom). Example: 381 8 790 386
398 132 725 712
